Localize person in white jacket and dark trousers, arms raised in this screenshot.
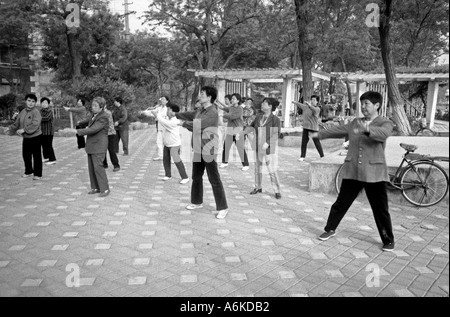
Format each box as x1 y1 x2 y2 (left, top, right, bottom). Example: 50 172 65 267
153 103 189 184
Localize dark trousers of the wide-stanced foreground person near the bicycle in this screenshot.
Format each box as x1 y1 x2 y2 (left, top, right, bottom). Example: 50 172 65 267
325 179 394 244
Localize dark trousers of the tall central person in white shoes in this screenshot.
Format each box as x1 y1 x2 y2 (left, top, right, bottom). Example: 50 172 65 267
191 157 228 211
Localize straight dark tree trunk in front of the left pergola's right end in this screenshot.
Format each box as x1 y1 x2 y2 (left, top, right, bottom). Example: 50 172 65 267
295 0 314 101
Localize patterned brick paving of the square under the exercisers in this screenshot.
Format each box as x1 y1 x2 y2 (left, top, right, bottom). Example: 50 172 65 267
0 129 449 297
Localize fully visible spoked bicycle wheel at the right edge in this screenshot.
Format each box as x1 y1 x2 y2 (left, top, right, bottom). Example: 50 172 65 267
400 161 448 207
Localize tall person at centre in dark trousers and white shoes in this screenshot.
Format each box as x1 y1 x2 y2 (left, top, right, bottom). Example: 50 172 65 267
176 86 228 219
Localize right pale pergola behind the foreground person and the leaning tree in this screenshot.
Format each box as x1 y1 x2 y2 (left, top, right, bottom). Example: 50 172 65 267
333 71 449 129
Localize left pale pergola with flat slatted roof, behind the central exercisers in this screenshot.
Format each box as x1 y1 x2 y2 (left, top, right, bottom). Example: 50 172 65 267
189 68 331 127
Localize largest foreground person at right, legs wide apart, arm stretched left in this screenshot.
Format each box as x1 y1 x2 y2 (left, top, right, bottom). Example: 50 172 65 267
312 91 395 251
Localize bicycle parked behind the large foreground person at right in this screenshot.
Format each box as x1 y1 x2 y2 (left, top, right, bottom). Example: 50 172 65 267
335 143 449 207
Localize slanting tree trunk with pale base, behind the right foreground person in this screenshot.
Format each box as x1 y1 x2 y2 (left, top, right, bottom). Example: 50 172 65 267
378 0 411 135
